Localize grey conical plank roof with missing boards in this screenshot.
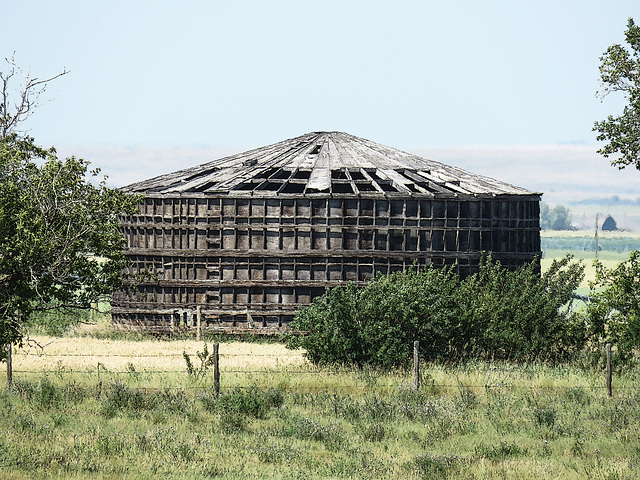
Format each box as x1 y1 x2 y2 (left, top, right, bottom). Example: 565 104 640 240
122 132 540 196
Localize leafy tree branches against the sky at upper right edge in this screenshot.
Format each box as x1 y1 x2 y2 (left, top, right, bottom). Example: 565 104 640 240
593 18 640 170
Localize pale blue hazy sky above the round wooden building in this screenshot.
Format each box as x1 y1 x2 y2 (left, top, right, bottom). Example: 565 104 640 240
0 0 640 208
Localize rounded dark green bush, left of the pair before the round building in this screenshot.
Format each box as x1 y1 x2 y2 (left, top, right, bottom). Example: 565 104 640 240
288 269 457 368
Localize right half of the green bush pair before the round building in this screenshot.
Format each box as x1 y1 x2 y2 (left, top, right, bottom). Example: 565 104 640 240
452 256 585 361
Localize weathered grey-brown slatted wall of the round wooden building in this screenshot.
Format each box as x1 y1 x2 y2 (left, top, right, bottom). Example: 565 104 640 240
113 192 540 332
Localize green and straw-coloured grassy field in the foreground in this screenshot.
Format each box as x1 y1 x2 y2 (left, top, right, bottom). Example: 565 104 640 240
0 337 640 479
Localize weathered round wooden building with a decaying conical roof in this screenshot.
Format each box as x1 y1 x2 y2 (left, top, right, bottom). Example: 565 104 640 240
112 132 540 333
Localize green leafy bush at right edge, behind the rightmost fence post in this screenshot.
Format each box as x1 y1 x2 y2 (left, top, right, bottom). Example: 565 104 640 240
588 250 640 355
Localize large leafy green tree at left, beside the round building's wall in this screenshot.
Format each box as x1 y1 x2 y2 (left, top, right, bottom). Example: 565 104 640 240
0 134 138 358
